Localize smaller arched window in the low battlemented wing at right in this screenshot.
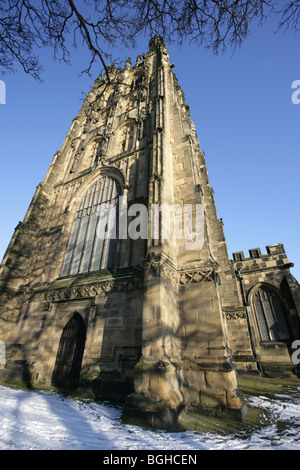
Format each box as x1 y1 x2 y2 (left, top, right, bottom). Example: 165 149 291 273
253 285 289 341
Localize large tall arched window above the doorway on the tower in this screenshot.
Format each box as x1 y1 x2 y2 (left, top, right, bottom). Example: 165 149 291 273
62 176 120 276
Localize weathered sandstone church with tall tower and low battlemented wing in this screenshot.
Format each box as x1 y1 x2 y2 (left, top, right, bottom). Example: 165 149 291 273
0 37 300 425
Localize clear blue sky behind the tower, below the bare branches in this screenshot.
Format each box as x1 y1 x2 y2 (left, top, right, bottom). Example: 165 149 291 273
0 15 300 280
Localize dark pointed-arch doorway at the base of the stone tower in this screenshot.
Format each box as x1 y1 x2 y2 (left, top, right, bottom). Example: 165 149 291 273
52 313 86 388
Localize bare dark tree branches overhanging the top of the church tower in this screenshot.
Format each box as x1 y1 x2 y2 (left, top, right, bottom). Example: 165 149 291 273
0 0 300 80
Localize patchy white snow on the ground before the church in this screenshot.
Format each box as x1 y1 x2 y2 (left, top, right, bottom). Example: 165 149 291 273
0 386 300 451
